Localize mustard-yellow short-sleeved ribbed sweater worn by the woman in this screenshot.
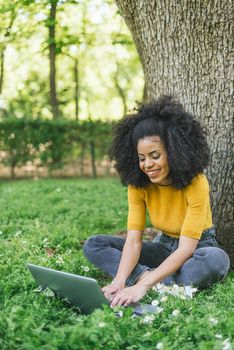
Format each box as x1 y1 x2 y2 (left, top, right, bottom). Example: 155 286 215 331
128 175 212 239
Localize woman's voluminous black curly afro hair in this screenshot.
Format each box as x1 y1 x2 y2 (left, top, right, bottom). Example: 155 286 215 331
109 96 209 189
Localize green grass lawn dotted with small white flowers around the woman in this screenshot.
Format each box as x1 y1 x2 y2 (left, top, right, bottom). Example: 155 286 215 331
0 179 234 350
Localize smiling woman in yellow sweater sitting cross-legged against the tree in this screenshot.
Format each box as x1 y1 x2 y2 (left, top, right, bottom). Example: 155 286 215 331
84 96 230 306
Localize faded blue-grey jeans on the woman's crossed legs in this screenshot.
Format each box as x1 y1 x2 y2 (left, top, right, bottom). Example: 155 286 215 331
83 227 230 288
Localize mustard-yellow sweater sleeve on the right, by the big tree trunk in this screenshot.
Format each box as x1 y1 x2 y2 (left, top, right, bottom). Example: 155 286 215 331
181 175 209 239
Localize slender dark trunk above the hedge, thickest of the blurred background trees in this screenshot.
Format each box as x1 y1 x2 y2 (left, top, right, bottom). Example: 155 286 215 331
48 0 59 119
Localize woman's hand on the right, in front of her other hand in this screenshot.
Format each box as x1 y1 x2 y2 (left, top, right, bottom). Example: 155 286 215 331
111 284 147 307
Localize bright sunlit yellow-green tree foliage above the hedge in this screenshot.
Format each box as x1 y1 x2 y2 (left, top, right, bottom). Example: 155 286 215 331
0 0 143 119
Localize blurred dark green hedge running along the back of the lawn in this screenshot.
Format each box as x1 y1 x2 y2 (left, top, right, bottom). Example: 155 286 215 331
0 118 112 176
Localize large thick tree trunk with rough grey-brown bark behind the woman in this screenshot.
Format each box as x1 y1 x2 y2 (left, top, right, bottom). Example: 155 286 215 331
116 0 234 266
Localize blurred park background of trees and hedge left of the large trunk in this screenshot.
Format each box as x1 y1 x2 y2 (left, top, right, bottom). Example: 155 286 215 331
0 0 144 178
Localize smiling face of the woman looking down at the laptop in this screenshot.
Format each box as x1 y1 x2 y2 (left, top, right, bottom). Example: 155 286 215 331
137 136 171 186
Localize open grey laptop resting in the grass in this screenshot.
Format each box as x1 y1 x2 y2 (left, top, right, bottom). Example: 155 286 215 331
27 263 156 315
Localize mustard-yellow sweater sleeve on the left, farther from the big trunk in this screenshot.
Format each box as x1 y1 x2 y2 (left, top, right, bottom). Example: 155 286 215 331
127 185 146 231
